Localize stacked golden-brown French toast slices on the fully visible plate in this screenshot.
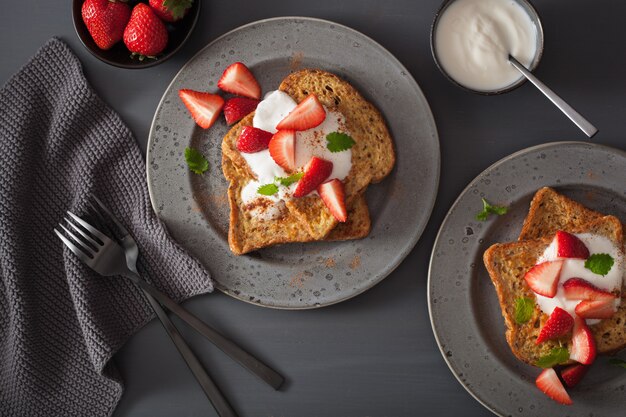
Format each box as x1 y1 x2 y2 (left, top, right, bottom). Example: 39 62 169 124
222 70 395 254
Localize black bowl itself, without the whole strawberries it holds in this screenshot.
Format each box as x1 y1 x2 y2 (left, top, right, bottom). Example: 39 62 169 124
72 0 201 69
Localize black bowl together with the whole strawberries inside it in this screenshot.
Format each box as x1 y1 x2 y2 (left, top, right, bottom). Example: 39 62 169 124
72 0 200 69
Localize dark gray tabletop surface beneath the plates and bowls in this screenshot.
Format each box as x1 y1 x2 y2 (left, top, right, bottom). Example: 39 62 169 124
0 0 626 417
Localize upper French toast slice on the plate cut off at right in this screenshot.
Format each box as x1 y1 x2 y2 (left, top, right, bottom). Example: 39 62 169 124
483 211 626 365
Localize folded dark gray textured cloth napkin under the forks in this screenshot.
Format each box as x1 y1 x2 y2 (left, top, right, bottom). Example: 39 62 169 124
0 39 213 417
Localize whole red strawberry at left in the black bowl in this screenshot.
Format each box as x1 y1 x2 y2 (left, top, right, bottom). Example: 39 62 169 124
81 0 130 50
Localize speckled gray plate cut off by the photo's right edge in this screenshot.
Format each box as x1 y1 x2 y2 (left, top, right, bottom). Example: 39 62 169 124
428 142 626 417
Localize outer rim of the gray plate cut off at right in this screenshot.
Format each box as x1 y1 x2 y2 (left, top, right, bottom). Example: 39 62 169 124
427 141 626 417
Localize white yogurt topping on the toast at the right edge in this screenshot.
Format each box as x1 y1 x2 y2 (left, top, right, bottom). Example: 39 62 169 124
535 233 624 324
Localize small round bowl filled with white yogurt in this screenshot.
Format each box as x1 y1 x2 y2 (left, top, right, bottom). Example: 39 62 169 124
435 0 538 91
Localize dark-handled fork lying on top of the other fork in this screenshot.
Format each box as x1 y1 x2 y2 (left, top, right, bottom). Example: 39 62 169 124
55 206 284 398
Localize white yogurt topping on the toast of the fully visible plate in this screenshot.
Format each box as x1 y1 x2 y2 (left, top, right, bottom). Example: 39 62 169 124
241 90 352 219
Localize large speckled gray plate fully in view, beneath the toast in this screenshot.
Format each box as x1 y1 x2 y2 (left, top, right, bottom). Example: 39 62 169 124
147 17 439 309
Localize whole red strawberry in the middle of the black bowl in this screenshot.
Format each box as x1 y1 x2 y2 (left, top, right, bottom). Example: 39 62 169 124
124 3 167 60
